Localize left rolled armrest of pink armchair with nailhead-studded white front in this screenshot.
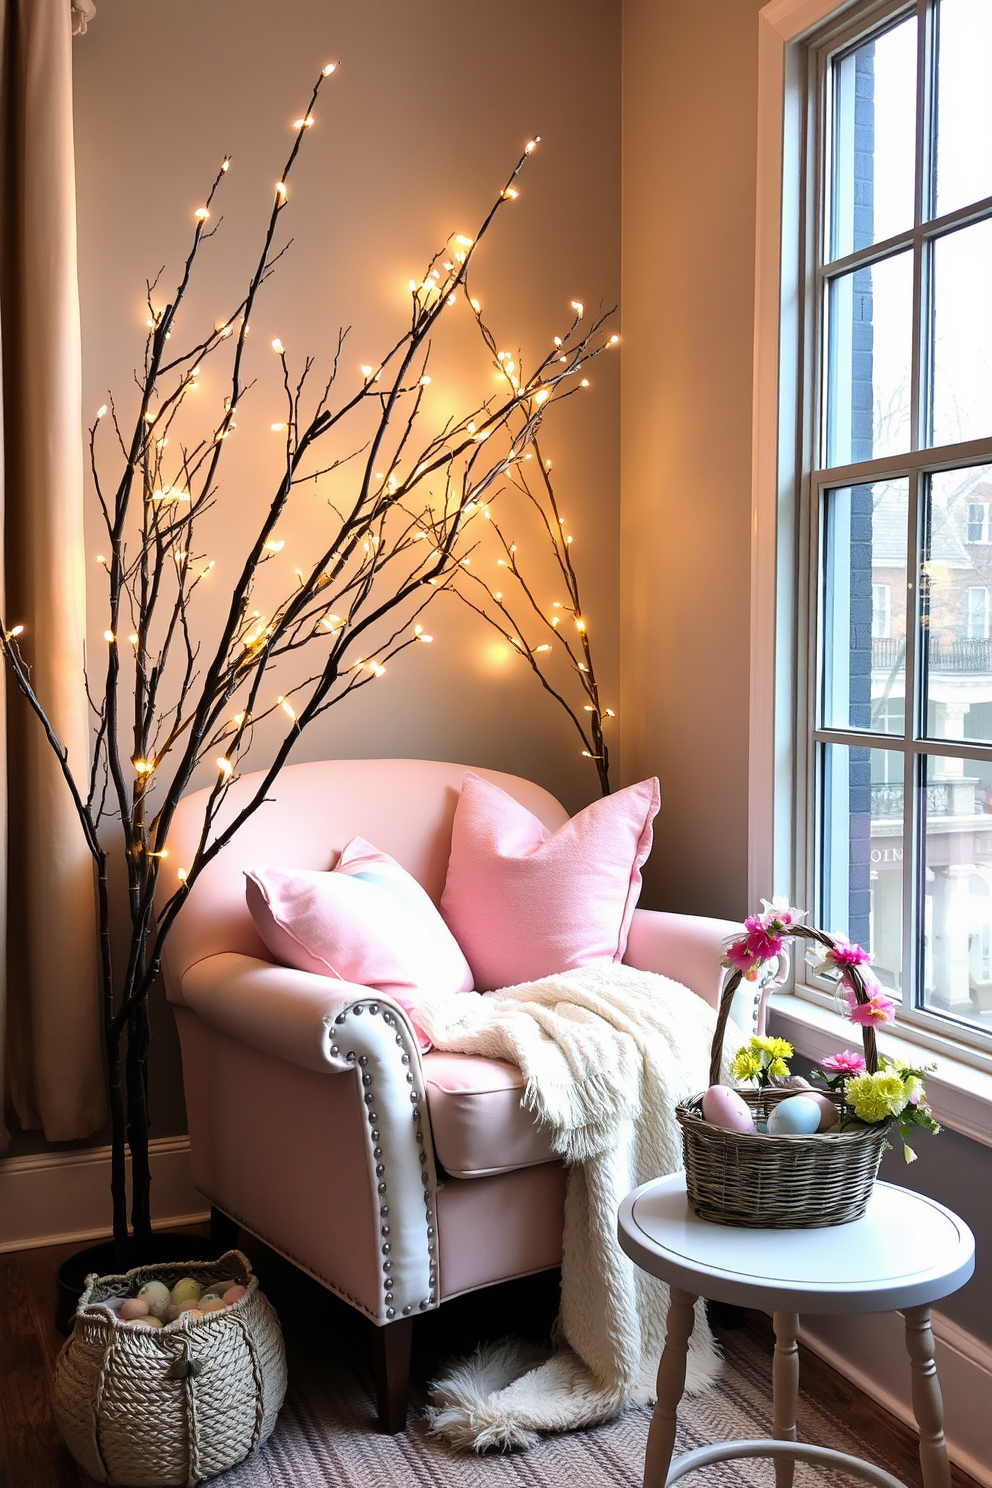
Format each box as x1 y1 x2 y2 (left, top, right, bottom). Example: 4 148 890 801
181 952 437 1323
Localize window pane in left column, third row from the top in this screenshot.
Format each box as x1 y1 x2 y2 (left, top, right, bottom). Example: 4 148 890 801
821 481 909 734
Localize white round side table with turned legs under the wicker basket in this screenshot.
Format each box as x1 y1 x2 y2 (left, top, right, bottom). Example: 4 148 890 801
619 1173 974 1488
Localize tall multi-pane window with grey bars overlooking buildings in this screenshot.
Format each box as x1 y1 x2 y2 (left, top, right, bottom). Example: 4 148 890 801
799 0 992 1045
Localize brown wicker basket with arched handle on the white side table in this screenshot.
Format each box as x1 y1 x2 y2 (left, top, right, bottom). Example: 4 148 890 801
675 926 888 1229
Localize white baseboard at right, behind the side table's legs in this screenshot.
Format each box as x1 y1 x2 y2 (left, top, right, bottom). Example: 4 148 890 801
802 1311 992 1488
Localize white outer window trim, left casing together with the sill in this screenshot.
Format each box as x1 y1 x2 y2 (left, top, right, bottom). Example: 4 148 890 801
748 0 992 1124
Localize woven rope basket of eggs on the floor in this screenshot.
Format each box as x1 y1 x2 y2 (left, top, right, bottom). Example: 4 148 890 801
54 1250 286 1488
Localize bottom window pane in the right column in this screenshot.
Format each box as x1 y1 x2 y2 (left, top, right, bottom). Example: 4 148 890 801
924 756 992 1028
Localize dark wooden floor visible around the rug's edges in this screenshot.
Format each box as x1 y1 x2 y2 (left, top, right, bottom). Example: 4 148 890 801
0 1231 979 1488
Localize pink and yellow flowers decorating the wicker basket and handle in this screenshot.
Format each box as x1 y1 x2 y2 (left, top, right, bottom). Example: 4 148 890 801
723 900 940 1162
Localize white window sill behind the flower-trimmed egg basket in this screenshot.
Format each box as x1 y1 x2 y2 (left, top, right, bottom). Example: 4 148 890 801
769 992 992 1147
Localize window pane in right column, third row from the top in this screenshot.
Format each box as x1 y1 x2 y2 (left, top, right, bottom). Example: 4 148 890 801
921 466 992 743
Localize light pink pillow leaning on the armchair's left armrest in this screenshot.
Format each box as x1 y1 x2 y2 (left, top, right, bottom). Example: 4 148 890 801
244 838 471 1049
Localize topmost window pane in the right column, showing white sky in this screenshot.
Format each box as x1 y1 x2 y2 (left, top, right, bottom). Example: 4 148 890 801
935 0 992 217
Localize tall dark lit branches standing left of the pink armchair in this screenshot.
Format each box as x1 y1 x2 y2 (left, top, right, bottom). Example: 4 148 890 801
0 64 608 1262
